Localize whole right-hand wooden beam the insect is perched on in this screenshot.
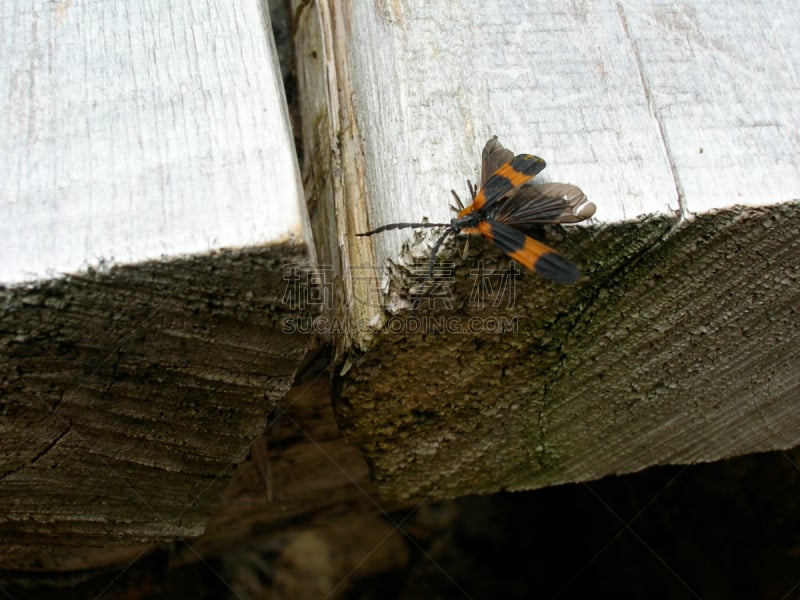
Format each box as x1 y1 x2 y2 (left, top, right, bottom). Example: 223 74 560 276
297 0 800 498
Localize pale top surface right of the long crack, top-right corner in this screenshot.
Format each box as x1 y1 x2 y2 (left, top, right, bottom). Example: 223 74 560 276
619 0 800 213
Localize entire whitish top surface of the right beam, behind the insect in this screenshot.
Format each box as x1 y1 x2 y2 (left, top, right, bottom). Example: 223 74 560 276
348 0 800 272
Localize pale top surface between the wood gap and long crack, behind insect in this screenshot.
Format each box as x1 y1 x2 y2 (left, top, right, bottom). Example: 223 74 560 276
349 0 678 272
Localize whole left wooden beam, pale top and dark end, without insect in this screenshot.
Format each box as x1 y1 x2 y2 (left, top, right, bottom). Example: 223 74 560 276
0 0 313 569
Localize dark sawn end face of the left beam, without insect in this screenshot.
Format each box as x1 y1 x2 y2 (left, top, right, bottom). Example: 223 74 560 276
0 247 308 569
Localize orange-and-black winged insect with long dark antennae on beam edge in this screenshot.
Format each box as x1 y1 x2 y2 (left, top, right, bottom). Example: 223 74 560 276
357 136 595 283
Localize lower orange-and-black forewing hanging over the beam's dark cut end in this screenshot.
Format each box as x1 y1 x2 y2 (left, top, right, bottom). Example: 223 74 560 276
478 220 581 283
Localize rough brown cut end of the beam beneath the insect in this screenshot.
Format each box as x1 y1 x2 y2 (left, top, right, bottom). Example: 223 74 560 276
337 203 800 498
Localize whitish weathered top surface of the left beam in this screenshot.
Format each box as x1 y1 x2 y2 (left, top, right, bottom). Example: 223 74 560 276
0 0 306 283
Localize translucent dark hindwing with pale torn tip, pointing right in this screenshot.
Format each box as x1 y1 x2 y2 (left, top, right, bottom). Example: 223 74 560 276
491 183 596 228
